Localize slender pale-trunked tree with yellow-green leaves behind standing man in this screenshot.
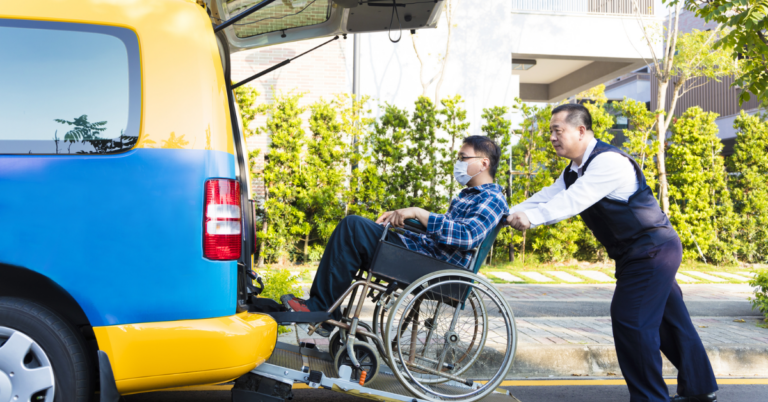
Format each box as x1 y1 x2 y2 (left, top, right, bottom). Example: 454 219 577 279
635 1 738 215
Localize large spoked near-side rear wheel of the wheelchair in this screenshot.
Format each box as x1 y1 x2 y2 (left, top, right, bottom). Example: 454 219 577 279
384 270 517 401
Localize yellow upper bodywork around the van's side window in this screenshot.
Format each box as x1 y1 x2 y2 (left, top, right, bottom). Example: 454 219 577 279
0 0 234 154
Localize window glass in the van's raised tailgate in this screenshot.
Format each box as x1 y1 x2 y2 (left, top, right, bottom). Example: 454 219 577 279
224 0 332 38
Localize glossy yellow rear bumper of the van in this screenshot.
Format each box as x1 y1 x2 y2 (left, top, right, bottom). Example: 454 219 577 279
93 312 277 395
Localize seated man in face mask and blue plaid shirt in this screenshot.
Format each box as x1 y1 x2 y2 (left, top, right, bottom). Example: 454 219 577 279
280 135 508 337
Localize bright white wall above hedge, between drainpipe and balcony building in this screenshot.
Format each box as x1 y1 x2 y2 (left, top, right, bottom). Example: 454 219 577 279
346 0 519 134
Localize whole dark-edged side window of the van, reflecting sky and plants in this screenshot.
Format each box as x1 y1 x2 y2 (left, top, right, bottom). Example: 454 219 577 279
0 19 141 155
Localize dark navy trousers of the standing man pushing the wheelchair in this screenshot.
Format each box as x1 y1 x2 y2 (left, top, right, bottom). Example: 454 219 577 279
611 238 718 402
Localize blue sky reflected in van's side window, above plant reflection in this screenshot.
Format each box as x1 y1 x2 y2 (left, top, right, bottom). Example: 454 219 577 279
0 27 128 140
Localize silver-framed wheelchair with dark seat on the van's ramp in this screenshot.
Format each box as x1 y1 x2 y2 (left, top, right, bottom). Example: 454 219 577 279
312 219 517 402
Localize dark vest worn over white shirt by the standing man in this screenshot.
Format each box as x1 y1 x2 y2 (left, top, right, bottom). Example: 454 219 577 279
563 140 677 266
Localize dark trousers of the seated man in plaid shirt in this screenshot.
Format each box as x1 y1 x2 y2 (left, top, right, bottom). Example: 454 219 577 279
307 215 405 320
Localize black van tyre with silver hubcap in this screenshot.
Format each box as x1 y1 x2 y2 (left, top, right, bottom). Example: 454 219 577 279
0 297 93 402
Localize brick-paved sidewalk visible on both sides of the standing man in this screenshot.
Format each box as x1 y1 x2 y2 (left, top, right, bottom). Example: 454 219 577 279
280 284 768 378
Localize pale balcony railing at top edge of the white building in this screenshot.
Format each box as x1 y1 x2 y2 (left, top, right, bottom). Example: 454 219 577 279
512 0 654 15
